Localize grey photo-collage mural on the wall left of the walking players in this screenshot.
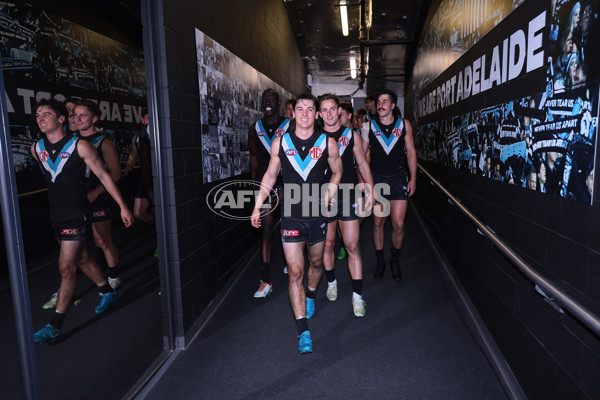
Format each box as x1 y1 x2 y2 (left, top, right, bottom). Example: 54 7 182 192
196 29 295 183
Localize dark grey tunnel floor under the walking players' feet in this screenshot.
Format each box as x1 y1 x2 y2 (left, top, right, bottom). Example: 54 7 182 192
147 210 506 400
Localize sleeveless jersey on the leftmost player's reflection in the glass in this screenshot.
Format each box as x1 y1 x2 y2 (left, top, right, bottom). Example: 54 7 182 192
35 136 89 221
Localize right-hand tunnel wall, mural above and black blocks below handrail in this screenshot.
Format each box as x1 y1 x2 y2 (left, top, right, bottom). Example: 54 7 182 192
407 1 600 399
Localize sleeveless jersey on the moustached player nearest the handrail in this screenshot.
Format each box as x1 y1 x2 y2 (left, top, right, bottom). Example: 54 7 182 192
369 118 406 176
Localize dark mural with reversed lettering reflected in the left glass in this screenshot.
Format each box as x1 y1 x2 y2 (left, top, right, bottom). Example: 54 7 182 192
0 2 146 192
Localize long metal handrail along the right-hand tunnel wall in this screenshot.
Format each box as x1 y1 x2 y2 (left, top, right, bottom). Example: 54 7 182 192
417 163 600 336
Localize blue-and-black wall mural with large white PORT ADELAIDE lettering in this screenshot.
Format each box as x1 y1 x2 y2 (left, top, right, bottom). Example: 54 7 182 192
414 0 600 204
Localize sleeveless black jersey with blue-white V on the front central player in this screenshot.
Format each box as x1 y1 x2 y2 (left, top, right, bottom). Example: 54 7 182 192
278 130 329 221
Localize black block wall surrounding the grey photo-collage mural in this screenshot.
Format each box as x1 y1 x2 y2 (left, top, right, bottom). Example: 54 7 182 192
152 0 306 333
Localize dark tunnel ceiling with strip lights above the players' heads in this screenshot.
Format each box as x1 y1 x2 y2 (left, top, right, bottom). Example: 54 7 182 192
284 0 431 94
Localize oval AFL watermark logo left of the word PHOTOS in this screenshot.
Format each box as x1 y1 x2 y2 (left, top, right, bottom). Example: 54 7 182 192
206 180 279 221
